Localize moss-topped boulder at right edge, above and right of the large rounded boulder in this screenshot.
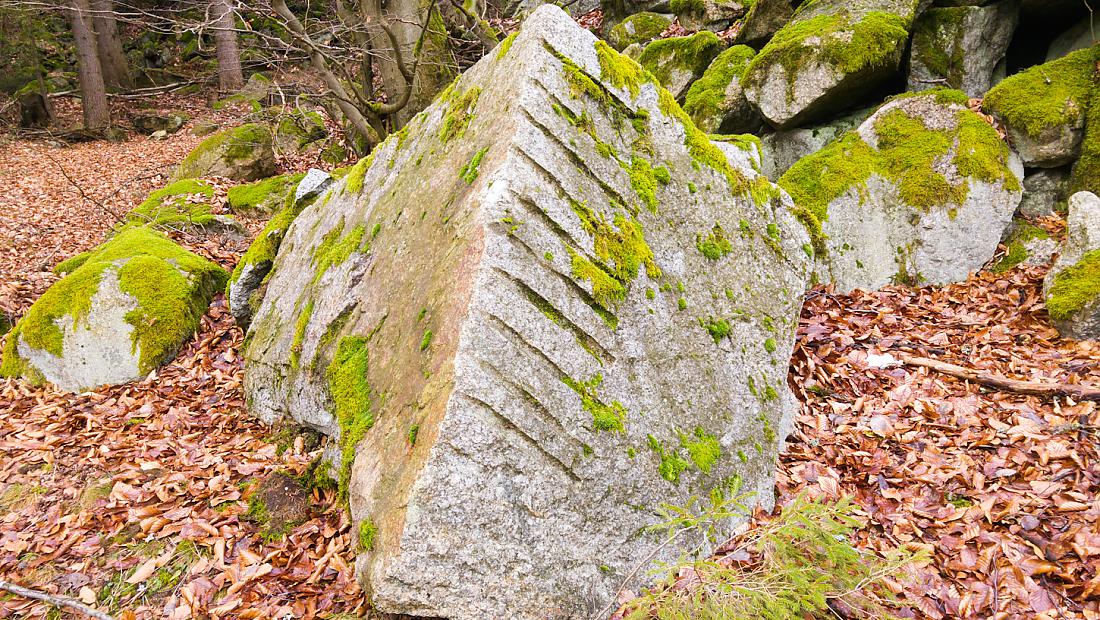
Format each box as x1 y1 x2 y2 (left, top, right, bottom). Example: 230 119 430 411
982 46 1100 167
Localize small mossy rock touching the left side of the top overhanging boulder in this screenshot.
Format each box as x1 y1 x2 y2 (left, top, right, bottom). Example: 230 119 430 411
684 45 762 133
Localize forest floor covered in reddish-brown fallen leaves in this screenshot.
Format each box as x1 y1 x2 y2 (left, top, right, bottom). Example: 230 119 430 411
0 93 1100 620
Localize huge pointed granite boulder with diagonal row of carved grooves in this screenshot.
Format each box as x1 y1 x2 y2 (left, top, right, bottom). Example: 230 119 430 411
244 7 809 620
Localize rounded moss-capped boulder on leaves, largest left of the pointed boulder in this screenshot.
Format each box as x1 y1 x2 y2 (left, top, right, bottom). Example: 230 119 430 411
0 226 228 391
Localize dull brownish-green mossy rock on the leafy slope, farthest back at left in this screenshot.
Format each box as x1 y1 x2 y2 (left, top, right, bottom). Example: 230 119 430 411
173 123 276 181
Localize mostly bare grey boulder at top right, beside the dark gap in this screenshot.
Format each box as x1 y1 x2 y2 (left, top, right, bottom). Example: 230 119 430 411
909 0 1020 97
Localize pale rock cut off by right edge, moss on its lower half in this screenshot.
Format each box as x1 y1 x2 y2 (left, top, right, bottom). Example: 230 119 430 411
1043 191 1100 340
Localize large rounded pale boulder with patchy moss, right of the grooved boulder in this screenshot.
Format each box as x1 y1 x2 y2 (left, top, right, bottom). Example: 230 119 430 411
779 90 1023 290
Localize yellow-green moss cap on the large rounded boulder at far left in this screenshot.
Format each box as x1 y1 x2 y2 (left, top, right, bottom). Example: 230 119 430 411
0 226 228 376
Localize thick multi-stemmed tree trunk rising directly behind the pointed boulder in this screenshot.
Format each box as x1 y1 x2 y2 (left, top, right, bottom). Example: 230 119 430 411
362 0 458 129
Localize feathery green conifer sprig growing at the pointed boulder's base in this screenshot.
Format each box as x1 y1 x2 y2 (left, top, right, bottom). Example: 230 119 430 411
626 494 919 620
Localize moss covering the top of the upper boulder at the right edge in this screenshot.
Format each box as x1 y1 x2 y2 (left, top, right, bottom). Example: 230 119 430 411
981 47 1100 139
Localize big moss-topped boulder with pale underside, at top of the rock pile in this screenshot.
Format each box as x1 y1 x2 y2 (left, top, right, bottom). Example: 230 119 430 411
745 0 919 129
